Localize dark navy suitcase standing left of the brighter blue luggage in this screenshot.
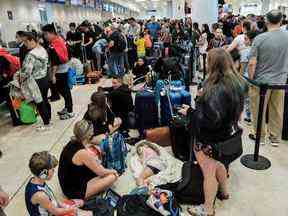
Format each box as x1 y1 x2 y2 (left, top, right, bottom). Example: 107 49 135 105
135 90 159 135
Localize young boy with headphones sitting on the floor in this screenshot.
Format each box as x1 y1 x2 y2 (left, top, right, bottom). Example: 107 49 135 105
25 151 84 216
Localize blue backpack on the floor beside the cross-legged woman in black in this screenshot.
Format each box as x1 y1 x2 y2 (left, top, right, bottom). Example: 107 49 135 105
100 132 128 175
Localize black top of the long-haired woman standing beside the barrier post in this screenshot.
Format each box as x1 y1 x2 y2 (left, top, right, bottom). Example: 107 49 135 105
188 78 246 144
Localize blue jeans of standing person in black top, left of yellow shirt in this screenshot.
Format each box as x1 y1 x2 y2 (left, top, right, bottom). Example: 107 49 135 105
108 52 125 76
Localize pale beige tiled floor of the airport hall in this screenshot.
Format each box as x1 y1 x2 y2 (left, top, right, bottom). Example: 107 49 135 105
0 80 288 216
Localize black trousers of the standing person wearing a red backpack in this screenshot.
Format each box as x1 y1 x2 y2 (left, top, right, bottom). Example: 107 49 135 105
56 73 73 113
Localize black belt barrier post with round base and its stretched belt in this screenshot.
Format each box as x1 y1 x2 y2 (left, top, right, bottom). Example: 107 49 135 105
241 78 288 170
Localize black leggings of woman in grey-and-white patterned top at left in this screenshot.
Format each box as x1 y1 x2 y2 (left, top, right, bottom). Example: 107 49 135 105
36 77 51 125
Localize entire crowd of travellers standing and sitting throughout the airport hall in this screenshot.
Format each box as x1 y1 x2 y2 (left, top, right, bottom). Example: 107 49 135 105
0 7 288 216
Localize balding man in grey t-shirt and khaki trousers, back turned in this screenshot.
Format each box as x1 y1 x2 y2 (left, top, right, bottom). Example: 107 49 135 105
248 10 288 147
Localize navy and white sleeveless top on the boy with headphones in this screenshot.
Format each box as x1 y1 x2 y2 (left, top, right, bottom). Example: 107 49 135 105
25 179 58 216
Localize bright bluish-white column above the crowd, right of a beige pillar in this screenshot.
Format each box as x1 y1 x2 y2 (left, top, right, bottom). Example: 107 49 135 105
192 0 218 25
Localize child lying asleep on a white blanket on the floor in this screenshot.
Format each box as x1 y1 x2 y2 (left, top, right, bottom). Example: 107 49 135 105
130 140 182 186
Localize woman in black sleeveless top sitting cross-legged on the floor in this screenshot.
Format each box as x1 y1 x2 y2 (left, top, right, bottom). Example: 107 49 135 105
58 120 118 199
